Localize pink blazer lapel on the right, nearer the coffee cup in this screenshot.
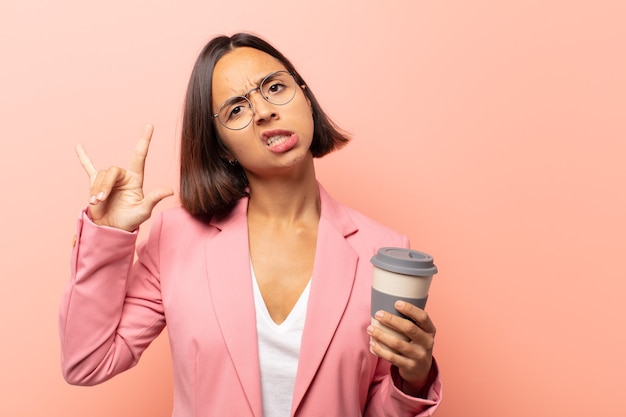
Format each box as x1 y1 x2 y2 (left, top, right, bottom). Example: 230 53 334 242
292 185 358 410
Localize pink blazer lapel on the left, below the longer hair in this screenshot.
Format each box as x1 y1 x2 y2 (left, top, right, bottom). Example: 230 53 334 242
206 198 262 417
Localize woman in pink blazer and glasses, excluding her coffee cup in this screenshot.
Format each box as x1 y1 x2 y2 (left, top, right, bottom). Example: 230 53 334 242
60 34 441 417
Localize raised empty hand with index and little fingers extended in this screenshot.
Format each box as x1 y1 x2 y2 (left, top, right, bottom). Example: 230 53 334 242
76 124 174 232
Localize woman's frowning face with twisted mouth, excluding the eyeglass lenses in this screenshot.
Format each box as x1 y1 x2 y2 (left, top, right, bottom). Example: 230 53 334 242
212 47 313 179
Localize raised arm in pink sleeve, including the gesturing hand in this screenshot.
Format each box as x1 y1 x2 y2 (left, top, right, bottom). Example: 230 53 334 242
59 125 172 385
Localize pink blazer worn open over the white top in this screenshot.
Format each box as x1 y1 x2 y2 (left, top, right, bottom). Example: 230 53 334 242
59 186 441 417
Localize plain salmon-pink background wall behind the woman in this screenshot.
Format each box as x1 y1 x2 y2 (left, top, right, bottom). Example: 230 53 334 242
0 0 626 417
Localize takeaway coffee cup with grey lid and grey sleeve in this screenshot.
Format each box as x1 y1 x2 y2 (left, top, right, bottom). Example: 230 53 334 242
371 247 437 340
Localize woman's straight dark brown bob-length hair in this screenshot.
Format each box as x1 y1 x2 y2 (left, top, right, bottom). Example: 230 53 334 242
180 33 349 218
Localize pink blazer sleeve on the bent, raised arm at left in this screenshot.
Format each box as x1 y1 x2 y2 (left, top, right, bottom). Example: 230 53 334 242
59 211 165 385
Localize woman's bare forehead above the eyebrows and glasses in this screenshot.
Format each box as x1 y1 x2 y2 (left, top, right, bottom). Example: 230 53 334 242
211 47 286 103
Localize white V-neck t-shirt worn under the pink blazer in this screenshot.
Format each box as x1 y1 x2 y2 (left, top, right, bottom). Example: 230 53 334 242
251 266 311 417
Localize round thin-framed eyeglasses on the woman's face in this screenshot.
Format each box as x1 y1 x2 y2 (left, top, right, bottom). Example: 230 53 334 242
213 71 297 130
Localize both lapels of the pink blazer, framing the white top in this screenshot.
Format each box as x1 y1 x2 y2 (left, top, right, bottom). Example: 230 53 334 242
206 184 358 417
